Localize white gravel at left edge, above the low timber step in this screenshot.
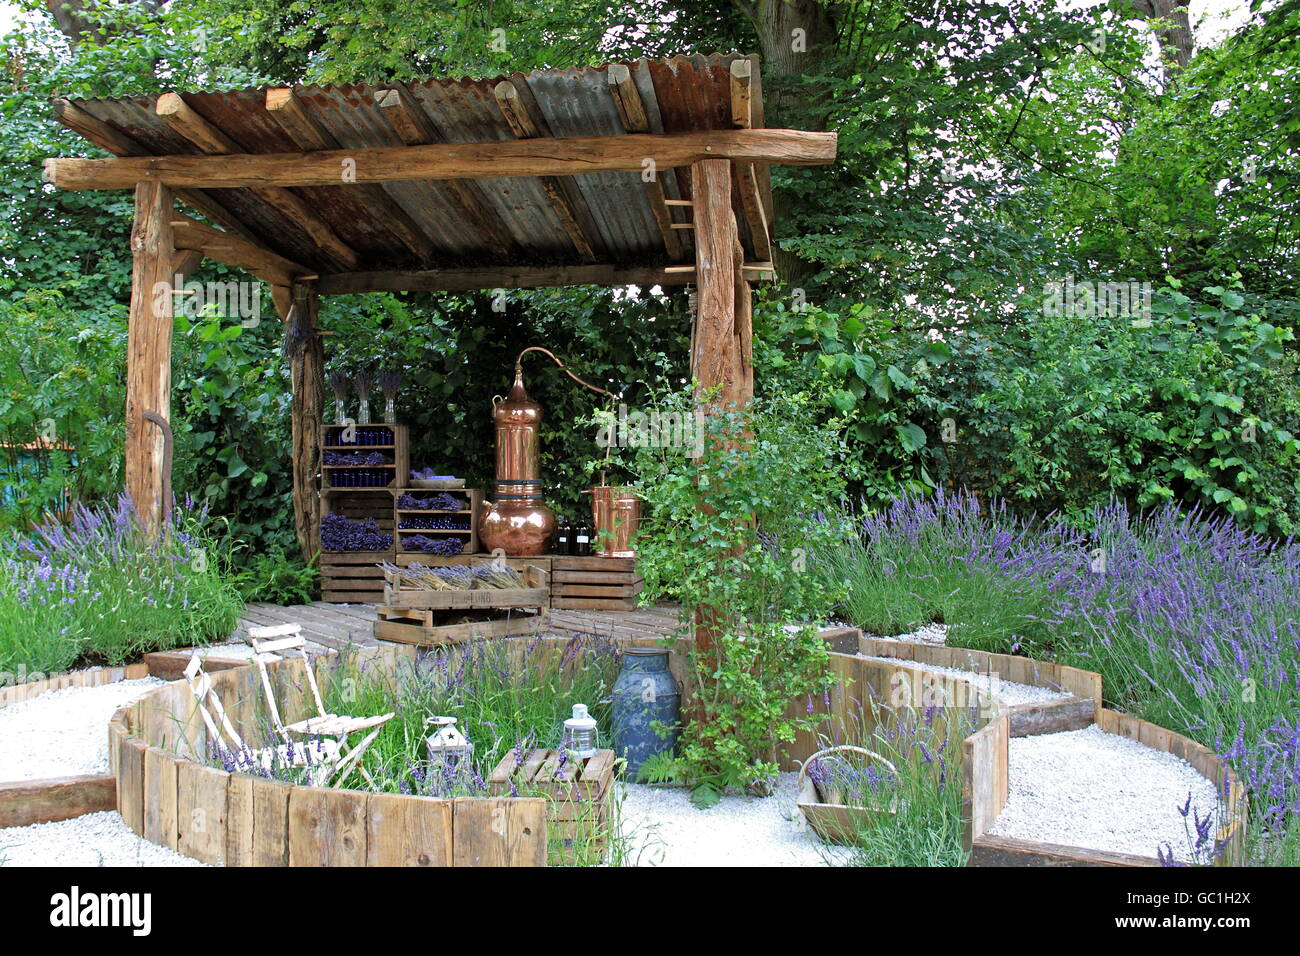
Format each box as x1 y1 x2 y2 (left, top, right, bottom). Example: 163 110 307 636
0 678 163 780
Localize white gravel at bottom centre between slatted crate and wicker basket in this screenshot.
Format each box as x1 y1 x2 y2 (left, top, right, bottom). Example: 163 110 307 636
620 773 850 866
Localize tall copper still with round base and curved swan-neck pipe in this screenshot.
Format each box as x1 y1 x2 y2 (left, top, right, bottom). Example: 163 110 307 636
478 345 615 558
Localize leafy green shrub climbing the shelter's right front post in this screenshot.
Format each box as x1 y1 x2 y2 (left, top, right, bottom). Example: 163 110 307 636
629 394 842 803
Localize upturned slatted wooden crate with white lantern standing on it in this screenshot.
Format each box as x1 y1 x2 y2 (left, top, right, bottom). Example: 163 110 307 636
488 750 618 864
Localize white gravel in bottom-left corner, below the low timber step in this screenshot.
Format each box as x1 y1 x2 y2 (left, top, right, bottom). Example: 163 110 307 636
0 810 204 866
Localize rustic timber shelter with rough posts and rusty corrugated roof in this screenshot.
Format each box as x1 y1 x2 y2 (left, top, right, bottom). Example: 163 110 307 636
46 55 836 587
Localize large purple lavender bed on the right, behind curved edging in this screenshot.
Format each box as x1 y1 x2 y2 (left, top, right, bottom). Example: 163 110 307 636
820 493 1300 865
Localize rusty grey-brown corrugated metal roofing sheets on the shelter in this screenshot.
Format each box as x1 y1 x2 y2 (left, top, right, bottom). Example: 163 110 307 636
58 53 761 273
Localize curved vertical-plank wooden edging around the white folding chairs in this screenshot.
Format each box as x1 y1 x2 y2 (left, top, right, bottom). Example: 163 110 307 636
109 661 546 866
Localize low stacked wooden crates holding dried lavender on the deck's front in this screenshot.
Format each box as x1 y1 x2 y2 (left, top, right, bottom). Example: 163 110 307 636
374 564 550 646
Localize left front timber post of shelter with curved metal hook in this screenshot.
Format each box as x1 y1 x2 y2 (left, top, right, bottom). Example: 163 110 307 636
126 182 176 532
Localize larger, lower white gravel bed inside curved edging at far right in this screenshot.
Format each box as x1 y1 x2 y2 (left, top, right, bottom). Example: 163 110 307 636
991 726 1217 861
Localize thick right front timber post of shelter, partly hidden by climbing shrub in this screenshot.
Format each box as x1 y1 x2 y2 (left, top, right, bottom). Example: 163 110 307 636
690 160 748 653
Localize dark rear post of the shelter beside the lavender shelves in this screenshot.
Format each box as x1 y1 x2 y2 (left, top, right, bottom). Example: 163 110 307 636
283 282 325 561
